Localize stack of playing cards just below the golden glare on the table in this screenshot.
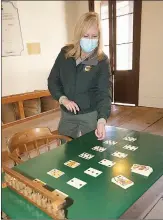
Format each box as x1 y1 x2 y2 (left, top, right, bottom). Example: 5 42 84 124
111 175 134 189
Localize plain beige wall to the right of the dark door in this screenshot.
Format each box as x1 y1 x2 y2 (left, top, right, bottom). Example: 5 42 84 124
139 1 163 108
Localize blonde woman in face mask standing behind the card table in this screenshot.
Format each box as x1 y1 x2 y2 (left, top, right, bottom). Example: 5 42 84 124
48 12 111 140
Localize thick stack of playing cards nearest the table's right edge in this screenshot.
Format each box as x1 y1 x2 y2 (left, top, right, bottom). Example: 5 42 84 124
131 164 153 176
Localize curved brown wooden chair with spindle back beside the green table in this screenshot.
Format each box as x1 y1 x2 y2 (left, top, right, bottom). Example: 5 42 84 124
7 128 72 164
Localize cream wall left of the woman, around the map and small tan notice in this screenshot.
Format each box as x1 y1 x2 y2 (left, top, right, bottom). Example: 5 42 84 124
2 1 67 96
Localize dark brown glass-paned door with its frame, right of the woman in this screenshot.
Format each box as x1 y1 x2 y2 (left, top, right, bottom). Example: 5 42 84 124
89 0 141 105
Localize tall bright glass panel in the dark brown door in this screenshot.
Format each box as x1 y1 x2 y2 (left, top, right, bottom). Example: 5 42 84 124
115 1 133 70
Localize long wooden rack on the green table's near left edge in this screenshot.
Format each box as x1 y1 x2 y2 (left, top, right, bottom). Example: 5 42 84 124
3 166 73 220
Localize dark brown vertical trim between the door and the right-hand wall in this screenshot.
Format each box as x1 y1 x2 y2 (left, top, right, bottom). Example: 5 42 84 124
133 0 142 106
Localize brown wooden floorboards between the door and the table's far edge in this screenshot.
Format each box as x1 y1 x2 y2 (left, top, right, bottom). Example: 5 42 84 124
107 105 163 136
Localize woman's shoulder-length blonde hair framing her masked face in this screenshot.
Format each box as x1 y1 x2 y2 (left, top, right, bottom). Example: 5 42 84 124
65 12 104 60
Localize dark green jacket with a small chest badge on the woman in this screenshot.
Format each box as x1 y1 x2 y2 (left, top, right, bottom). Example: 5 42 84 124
48 48 111 120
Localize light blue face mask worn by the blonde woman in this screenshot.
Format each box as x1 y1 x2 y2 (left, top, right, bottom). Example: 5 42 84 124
80 37 98 53
